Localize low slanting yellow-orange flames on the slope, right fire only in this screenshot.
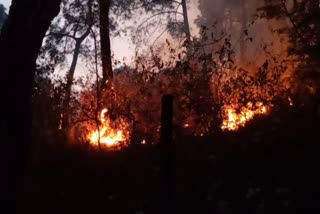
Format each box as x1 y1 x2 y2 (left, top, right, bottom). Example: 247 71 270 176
221 102 268 131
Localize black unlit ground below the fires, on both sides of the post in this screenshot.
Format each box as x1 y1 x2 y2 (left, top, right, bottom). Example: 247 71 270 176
25 106 320 214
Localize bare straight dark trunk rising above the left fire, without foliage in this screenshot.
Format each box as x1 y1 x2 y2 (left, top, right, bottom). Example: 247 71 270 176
99 0 113 89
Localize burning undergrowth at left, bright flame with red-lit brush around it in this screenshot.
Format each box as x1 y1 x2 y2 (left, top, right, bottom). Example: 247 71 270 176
69 88 132 150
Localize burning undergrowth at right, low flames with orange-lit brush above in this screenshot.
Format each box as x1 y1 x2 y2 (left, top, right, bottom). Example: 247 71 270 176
213 58 293 131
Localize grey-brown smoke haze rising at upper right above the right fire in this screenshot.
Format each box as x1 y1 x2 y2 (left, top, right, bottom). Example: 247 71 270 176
195 0 288 66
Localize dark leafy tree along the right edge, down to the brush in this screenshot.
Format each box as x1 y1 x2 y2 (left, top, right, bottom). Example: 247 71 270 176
259 0 320 102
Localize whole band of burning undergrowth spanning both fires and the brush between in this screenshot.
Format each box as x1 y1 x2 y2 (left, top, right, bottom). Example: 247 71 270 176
66 24 302 150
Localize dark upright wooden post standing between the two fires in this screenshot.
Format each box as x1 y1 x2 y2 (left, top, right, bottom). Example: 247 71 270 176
160 95 175 214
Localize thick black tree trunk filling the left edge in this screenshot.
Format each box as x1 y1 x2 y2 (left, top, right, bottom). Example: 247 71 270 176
0 0 61 213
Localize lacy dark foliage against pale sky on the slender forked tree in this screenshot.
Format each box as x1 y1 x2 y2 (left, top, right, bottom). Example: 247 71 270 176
38 0 98 72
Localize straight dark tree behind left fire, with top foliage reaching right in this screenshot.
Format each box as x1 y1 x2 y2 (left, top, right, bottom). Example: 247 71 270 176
98 0 190 125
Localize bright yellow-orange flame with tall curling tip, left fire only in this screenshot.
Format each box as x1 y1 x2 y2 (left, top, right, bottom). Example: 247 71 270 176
88 109 128 148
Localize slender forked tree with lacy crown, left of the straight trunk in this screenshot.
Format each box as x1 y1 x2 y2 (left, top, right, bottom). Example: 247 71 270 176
38 0 102 135
